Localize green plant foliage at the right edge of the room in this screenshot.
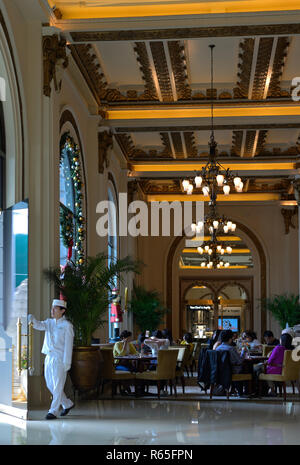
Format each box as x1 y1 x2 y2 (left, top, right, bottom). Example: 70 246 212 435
262 294 300 329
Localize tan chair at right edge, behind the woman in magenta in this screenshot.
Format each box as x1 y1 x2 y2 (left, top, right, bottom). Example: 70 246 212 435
259 350 300 402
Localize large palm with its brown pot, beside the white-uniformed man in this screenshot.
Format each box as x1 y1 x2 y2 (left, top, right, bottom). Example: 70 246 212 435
45 254 139 391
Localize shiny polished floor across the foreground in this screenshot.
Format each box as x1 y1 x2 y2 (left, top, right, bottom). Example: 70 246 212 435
0 400 300 445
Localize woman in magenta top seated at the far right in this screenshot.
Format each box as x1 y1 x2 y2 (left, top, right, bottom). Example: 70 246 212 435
254 333 294 396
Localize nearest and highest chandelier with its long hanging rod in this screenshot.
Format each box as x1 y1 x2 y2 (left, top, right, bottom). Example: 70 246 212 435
181 45 244 199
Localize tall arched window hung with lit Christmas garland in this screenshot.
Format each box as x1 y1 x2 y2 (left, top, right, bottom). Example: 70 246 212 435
59 133 85 266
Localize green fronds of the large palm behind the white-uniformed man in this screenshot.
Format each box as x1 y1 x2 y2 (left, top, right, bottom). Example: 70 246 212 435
44 254 139 346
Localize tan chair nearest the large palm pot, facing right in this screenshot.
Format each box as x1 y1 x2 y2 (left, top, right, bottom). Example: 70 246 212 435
100 348 135 397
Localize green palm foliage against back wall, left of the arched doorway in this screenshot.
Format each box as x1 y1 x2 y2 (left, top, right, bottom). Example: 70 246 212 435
129 285 169 331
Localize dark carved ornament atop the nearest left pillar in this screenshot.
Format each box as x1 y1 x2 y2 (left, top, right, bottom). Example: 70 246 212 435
43 34 69 97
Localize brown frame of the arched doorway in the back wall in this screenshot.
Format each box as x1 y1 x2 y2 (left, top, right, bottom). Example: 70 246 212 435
166 219 267 337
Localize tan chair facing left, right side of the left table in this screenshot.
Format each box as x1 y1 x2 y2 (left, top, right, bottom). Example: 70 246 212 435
136 349 178 399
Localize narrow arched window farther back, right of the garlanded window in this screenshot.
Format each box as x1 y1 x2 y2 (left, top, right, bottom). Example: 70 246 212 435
107 178 118 338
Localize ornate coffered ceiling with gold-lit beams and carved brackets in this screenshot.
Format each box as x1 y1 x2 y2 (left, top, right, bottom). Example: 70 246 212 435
44 0 300 198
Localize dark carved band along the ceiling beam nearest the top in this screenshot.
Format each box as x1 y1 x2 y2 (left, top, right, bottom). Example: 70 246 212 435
70 24 300 42
